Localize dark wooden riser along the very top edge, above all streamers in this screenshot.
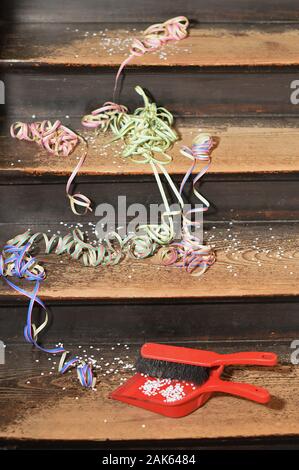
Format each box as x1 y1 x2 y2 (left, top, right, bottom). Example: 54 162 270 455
0 0 299 23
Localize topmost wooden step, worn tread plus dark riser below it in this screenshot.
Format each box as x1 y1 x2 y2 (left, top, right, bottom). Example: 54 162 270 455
0 24 299 118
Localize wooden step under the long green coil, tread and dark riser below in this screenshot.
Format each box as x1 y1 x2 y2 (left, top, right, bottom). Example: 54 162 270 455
0 223 299 344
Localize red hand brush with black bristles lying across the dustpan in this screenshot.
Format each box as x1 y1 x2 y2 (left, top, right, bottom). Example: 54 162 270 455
136 343 277 385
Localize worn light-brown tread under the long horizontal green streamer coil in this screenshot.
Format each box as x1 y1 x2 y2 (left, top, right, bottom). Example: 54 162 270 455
1 223 299 301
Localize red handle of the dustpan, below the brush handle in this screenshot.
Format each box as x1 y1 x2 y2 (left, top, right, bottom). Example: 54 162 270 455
202 380 271 403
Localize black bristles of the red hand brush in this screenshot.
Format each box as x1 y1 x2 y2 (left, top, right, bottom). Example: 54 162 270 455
136 355 210 385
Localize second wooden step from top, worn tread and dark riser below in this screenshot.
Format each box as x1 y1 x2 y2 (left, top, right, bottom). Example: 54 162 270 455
0 116 299 223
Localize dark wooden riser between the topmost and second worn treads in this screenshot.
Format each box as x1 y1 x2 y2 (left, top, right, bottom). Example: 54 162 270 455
0 66 299 120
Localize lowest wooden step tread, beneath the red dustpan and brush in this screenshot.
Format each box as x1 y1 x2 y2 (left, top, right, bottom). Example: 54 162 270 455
0 342 299 448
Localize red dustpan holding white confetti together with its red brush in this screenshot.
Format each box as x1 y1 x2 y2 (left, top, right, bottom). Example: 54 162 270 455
110 343 277 418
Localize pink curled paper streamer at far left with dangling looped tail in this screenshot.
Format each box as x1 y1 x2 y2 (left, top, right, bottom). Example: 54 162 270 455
10 120 91 215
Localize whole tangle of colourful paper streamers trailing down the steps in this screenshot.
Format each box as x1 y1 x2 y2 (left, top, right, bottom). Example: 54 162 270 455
0 16 215 387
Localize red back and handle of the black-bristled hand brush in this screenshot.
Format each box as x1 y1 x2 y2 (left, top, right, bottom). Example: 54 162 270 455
141 343 277 367
